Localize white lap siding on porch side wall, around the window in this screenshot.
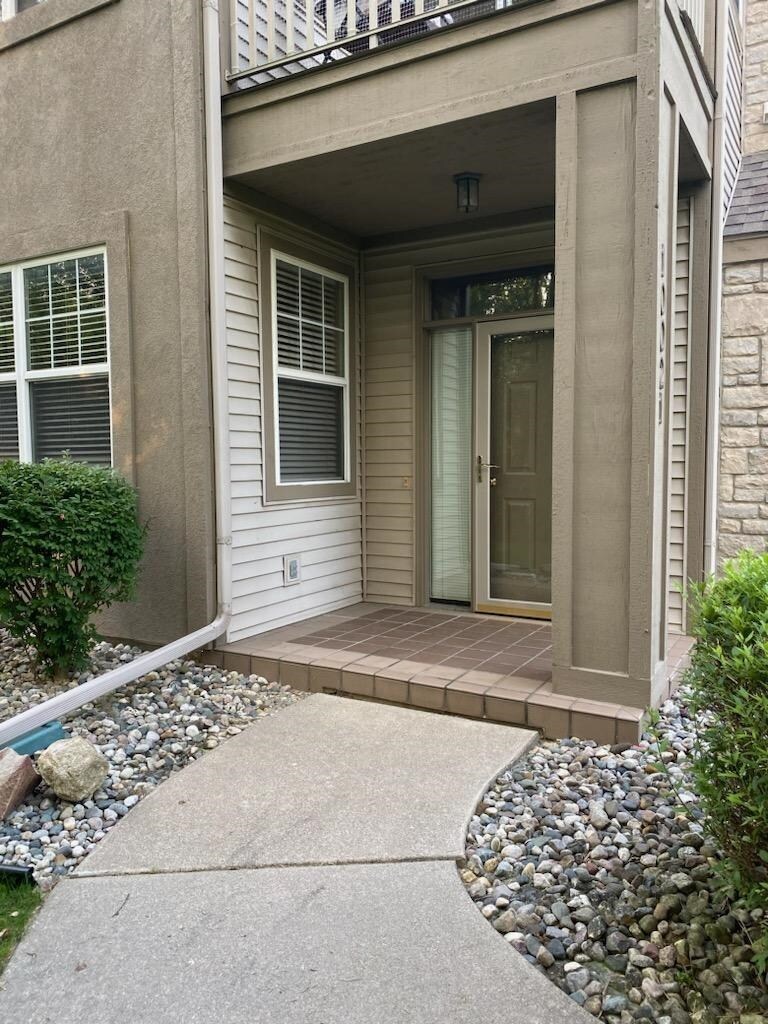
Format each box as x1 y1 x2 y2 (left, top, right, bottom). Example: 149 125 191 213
224 200 362 641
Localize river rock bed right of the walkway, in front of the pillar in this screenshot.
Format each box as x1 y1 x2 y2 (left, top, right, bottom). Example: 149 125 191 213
462 694 768 1024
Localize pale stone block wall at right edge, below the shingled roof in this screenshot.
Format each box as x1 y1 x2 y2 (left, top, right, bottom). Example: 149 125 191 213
718 259 768 560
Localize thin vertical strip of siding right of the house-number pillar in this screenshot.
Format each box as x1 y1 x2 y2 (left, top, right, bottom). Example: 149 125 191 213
668 199 691 633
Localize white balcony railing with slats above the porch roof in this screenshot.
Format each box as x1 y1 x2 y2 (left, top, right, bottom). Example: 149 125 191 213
228 0 537 84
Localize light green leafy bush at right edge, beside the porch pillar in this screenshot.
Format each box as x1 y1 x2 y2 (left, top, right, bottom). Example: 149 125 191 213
687 551 768 970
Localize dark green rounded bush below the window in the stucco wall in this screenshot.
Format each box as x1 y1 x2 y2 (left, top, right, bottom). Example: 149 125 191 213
0 460 143 675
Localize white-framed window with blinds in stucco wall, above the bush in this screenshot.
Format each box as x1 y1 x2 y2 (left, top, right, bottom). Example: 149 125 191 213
0 252 112 466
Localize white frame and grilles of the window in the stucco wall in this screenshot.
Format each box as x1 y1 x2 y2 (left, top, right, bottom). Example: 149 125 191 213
0 245 115 467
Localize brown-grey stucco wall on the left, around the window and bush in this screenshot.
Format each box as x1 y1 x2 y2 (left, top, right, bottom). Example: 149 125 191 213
0 0 213 643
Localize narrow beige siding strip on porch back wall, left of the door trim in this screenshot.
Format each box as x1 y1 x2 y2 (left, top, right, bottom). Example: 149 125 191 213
364 257 415 604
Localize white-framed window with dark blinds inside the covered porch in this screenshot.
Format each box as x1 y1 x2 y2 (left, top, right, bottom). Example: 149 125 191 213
272 253 348 483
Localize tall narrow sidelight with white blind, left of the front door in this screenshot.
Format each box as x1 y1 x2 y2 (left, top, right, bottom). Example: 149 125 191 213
430 327 472 603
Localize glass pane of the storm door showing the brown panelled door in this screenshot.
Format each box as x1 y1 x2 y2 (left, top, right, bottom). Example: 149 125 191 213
488 331 554 603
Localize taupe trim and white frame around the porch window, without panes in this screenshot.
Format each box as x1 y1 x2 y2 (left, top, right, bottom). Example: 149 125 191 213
257 226 358 505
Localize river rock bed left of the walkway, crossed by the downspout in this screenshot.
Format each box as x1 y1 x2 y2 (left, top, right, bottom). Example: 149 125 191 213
0 634 302 889
